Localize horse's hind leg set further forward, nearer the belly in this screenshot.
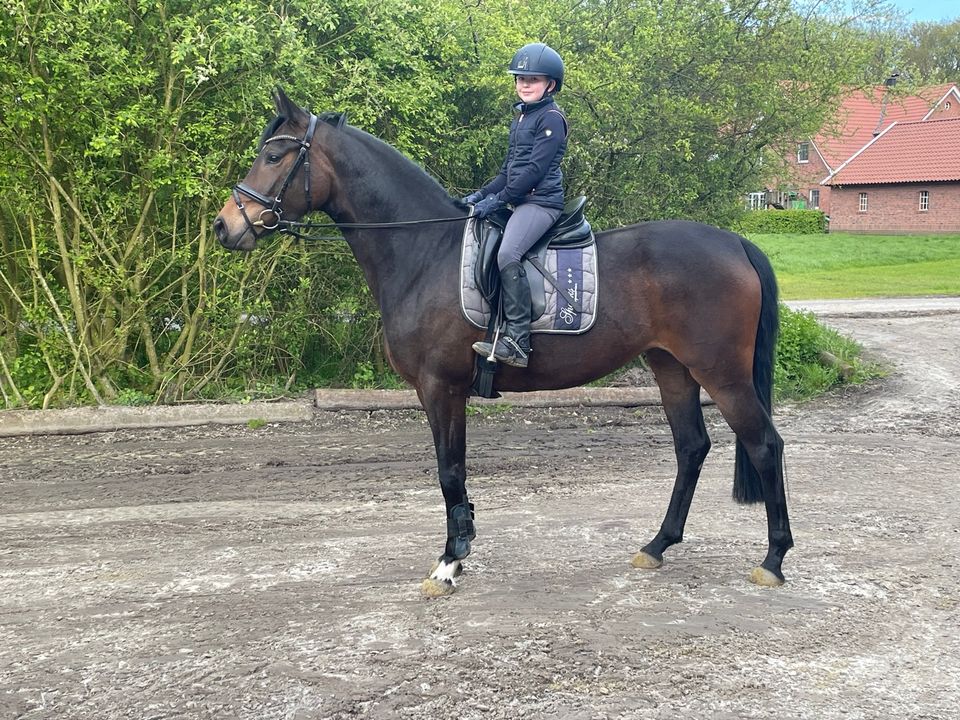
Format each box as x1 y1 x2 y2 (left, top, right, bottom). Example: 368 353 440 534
633 350 710 568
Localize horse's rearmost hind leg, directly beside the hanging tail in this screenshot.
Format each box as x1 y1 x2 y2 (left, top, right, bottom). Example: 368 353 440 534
706 382 793 586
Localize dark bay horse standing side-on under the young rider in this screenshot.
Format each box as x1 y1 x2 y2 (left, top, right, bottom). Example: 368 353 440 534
214 90 793 595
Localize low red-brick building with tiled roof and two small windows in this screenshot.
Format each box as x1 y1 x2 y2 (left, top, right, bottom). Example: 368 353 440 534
823 117 960 233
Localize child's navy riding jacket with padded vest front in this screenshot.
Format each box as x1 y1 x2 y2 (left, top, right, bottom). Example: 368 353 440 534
480 97 567 209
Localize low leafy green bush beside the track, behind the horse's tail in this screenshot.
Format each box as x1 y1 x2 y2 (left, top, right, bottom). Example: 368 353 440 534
774 305 882 400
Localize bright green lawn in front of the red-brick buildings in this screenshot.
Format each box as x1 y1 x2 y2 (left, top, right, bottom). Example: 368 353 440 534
750 233 960 300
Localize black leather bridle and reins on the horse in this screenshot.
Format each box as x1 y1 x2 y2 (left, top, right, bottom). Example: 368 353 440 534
233 113 472 240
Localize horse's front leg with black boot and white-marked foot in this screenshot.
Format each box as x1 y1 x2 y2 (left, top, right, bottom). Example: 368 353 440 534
417 383 477 597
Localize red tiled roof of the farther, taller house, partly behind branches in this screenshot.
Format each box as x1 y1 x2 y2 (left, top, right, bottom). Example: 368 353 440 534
814 84 955 170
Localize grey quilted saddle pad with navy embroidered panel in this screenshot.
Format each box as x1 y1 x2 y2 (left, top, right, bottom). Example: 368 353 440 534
460 219 598 335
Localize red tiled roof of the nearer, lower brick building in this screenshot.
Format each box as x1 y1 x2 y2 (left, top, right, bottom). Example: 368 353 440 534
825 118 960 185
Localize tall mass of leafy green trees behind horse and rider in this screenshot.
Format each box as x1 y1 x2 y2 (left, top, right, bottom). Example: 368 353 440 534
0 0 912 406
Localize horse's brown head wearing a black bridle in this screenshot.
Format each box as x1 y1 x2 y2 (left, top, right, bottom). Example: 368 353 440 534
213 88 342 250
